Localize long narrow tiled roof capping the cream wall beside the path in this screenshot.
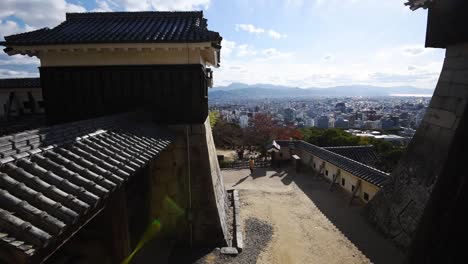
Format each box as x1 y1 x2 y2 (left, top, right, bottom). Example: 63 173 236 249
277 141 389 187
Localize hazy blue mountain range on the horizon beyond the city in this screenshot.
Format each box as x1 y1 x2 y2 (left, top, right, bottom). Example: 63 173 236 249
208 83 434 100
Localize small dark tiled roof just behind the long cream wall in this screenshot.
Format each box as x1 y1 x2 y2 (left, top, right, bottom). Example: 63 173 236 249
324 145 379 166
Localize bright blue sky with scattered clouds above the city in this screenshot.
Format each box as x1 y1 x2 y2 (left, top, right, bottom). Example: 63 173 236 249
0 0 444 89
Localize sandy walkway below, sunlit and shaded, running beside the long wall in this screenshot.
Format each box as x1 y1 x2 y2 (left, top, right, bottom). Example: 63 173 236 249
223 169 403 264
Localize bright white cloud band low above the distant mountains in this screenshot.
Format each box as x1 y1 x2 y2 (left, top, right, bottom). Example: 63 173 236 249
214 55 442 88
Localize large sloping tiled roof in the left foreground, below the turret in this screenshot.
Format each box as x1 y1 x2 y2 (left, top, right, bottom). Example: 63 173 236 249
0 114 172 258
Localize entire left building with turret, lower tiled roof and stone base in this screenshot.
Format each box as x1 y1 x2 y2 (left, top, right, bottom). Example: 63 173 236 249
0 12 232 264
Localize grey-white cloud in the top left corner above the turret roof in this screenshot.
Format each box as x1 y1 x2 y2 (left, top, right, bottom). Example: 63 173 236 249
0 0 86 28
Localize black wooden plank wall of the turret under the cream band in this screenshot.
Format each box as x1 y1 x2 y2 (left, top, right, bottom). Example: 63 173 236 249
40 64 208 124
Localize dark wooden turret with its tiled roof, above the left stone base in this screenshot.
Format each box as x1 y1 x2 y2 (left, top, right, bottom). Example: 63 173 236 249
2 12 221 124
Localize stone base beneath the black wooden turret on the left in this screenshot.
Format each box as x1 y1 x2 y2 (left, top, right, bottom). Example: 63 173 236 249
148 118 230 246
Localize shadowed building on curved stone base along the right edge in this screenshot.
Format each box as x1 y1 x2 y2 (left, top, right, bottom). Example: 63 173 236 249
368 0 468 263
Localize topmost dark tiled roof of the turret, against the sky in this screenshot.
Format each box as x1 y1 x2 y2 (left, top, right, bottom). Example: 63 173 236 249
3 12 221 46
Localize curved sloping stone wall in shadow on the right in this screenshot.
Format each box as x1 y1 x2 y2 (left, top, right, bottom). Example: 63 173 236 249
367 43 468 249
